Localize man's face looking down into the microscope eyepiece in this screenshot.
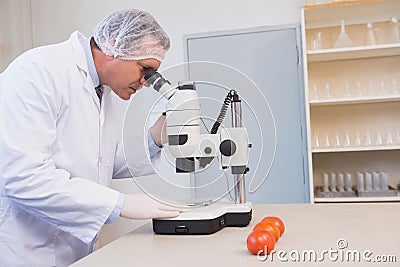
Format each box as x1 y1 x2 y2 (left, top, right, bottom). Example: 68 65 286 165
108 58 161 100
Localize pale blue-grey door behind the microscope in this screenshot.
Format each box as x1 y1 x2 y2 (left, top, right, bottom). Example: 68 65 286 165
185 25 310 203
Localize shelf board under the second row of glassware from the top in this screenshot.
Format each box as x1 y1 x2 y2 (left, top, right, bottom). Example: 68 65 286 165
309 95 400 107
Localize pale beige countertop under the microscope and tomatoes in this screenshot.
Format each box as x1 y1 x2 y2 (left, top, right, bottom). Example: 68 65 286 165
72 203 400 267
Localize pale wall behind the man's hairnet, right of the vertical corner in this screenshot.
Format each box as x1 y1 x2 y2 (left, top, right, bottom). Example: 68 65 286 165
31 0 304 68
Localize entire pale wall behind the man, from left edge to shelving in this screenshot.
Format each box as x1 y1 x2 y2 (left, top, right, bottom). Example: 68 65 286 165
0 0 305 71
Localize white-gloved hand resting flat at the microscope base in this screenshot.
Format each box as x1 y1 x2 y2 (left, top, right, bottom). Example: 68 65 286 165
120 194 186 220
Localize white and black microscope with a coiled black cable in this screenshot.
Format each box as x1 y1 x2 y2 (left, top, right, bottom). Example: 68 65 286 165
145 70 252 235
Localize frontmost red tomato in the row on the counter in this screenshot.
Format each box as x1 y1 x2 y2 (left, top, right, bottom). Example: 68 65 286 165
247 230 275 255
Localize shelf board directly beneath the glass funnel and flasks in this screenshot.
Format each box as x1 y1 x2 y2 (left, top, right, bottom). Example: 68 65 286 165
307 43 400 62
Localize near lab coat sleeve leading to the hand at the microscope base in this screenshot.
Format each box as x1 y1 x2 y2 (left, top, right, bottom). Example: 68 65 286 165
0 68 119 243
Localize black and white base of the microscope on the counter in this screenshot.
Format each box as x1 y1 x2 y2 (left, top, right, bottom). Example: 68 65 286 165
153 202 252 235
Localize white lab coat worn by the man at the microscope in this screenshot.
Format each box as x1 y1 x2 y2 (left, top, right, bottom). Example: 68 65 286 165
0 32 153 266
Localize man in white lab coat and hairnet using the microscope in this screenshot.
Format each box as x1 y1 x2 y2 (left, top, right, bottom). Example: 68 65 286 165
0 9 181 267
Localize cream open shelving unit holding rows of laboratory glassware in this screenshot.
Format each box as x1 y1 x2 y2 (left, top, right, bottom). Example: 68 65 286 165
301 0 400 202
